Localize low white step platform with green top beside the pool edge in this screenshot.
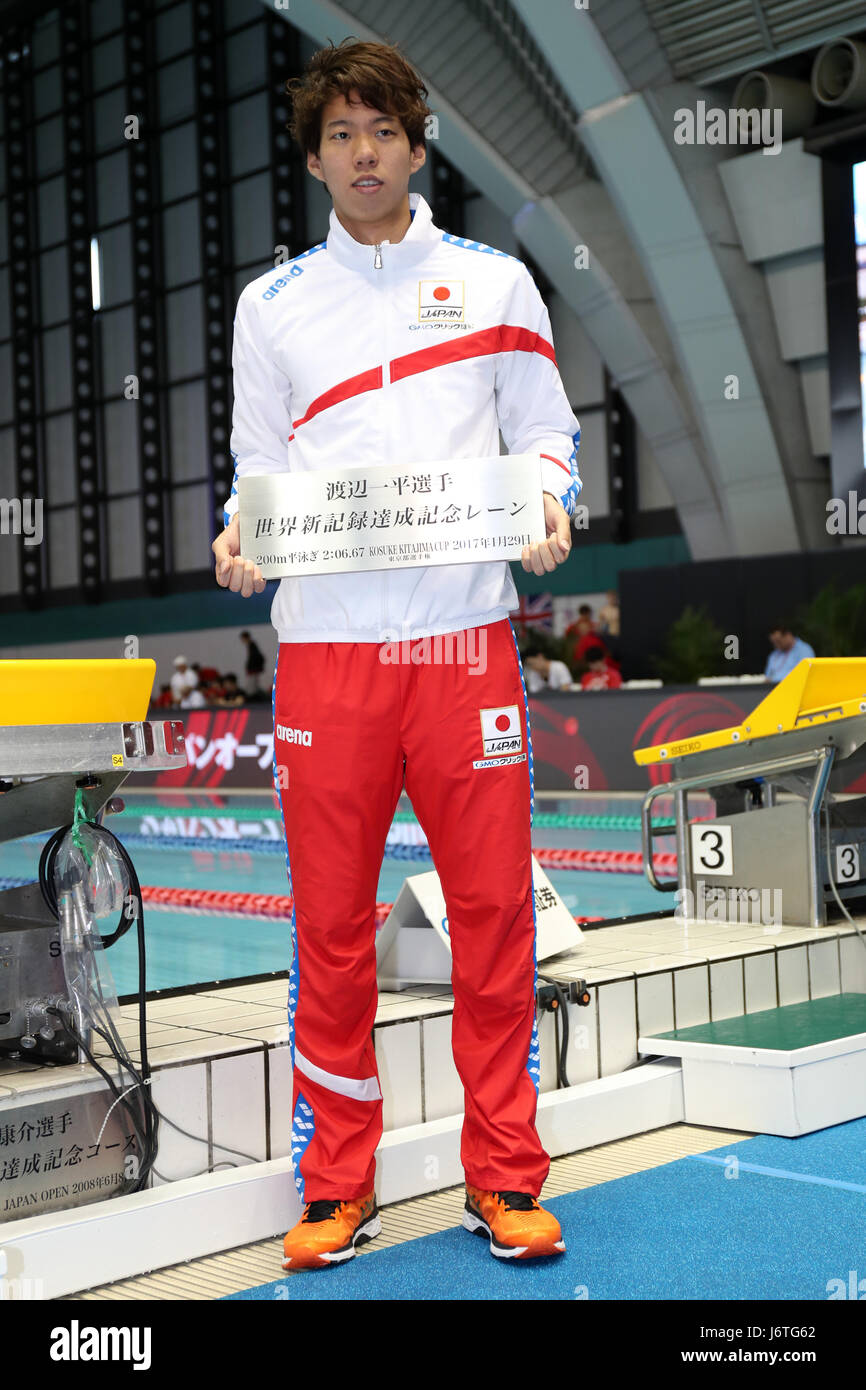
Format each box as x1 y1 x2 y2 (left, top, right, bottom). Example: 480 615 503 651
638 994 866 1138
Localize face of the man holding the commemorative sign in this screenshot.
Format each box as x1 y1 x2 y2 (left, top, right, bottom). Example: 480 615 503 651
307 92 427 222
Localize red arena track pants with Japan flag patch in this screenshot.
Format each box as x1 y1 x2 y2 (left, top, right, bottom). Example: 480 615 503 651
274 619 550 1202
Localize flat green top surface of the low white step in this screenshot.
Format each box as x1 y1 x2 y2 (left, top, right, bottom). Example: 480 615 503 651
644 994 866 1052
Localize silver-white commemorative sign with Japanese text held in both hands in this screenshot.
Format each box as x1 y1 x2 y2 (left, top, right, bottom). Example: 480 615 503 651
238 453 546 580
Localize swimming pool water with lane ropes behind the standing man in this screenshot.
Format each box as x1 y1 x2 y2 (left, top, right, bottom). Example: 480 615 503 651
0 787 683 997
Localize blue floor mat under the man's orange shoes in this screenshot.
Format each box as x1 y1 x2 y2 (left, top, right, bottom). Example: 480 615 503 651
222 1119 866 1302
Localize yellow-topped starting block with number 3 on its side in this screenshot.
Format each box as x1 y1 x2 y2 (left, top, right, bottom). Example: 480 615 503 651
634 657 866 926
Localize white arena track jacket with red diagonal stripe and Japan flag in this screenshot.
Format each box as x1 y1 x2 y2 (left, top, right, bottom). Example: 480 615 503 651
225 193 581 642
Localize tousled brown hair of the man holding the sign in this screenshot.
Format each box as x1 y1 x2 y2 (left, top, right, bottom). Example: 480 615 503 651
286 39 431 156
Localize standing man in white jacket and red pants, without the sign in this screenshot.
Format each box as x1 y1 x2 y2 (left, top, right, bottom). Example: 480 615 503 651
213 43 581 1269
